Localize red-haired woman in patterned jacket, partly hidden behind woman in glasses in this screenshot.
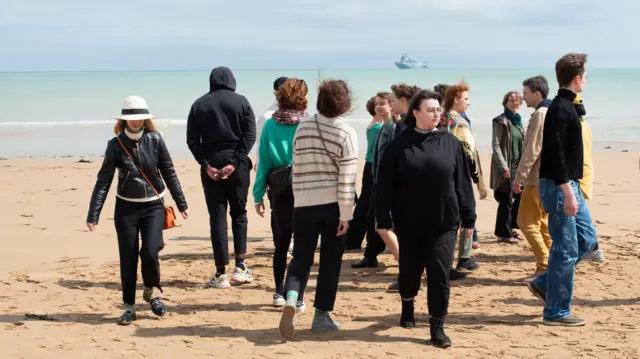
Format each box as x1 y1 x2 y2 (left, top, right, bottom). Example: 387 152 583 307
441 83 487 280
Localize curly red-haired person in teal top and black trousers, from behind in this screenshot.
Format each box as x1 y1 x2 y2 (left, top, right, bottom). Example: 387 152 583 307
253 79 309 312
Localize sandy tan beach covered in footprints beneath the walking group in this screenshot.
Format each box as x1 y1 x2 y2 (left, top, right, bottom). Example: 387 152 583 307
0 151 640 358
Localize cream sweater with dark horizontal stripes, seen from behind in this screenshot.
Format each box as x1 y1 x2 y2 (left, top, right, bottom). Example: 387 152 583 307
293 114 358 221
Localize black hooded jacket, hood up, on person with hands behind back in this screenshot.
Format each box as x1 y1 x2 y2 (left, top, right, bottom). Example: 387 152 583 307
187 67 256 169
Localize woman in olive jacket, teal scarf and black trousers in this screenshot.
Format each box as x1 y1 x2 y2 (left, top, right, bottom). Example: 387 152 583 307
491 91 524 244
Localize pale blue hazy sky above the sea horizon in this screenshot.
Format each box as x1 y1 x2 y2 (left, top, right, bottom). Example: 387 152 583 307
0 0 640 71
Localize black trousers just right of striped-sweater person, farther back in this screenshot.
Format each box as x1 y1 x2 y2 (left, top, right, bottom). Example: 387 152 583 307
346 162 385 260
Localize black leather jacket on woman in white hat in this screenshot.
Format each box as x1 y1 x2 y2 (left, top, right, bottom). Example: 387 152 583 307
87 130 187 224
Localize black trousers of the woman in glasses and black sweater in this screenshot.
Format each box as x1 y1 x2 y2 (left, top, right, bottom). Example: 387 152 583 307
397 224 458 317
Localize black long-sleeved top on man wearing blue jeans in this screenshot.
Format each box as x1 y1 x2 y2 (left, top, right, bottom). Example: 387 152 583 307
540 89 584 186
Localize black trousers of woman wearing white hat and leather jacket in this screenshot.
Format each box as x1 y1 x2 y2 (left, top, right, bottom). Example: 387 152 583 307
113 198 164 305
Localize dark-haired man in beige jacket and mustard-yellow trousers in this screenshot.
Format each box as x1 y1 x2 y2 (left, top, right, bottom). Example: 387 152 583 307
511 76 551 281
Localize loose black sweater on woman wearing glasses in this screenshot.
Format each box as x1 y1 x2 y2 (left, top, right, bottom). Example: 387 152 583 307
376 128 476 234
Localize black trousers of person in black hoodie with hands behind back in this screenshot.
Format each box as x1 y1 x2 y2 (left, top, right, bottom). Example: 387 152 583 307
200 165 250 268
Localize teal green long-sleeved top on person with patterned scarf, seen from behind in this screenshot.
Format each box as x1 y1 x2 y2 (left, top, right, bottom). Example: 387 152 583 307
253 118 298 204
